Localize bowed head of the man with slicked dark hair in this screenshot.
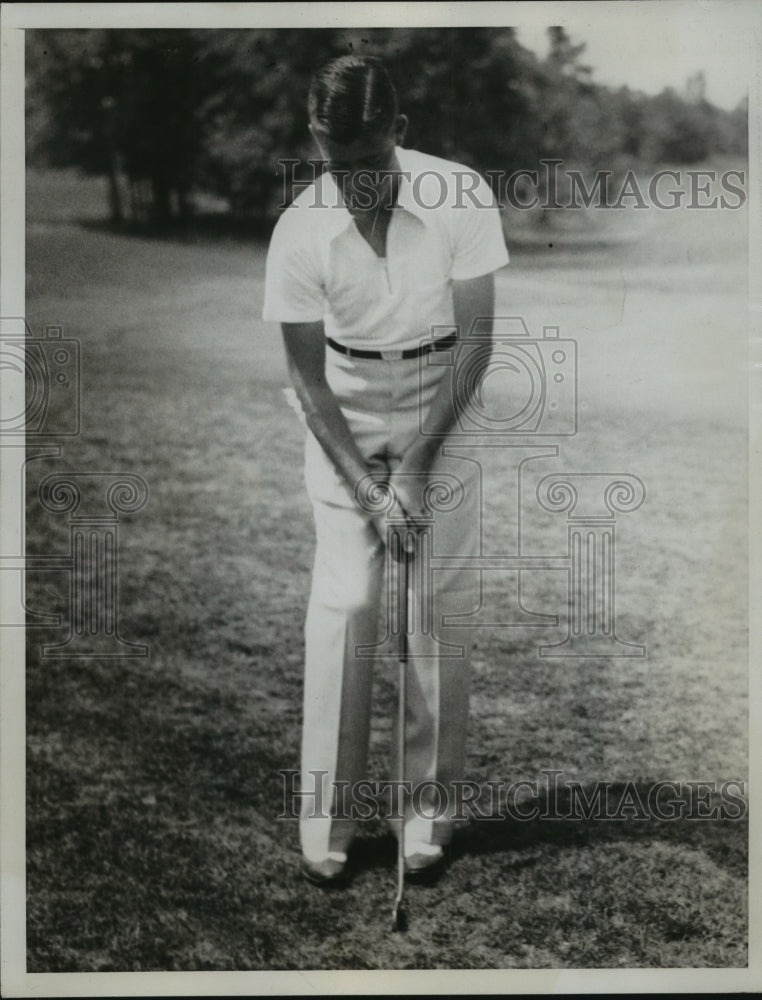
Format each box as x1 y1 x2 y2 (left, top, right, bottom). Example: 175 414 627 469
308 56 407 214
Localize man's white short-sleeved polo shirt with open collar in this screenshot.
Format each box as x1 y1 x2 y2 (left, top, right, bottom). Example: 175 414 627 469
262 147 508 350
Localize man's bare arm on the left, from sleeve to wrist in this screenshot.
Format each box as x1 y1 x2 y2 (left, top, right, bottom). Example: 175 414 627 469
281 320 388 538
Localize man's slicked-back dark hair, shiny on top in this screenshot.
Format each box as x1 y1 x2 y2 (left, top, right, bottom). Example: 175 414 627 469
308 56 397 142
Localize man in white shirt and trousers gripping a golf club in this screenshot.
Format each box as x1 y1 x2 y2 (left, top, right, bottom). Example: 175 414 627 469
263 56 508 884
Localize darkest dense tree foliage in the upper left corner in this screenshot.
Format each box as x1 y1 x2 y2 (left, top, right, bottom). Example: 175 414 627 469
27 30 211 221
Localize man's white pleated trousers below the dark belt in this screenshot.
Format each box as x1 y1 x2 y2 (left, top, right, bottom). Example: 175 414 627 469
300 347 480 857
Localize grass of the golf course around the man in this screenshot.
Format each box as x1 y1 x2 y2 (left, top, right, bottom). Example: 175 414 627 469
20 166 747 971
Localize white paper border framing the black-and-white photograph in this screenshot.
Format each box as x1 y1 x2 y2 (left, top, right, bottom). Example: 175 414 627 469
0 0 762 997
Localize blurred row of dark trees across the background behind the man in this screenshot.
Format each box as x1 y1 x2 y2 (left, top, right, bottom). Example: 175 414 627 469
26 27 747 222
